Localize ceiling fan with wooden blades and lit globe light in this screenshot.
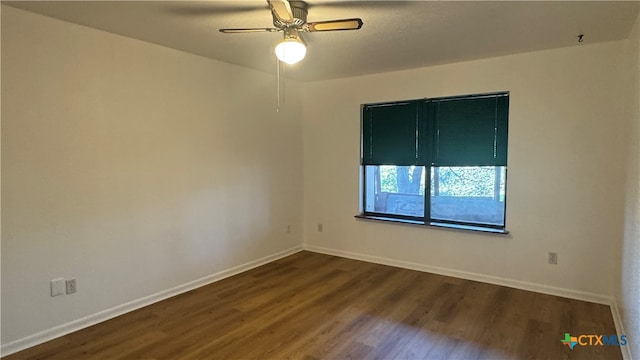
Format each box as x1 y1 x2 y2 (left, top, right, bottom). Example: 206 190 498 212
220 0 363 64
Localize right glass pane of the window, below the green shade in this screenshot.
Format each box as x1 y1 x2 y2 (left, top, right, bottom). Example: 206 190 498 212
431 166 506 226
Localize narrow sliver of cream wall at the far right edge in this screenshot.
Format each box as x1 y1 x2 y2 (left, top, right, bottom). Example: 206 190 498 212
615 11 640 359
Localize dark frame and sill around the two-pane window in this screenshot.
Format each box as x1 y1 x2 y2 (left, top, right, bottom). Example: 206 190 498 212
355 91 510 234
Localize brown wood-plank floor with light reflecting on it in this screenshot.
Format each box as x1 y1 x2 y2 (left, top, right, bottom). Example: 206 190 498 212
3 252 622 360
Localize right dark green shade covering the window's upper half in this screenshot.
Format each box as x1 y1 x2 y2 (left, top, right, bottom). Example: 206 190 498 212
426 94 509 166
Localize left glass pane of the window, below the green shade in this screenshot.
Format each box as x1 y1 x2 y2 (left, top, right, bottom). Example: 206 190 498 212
365 165 426 217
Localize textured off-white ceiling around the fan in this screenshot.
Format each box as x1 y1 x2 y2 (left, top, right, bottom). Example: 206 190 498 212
2 0 640 81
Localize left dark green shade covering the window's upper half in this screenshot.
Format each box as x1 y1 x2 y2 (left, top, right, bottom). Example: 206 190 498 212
362 101 418 166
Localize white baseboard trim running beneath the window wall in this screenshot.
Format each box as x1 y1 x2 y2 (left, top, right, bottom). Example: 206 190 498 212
303 244 611 305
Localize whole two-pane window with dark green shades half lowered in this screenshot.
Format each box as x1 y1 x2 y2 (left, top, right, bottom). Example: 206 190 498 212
361 93 509 231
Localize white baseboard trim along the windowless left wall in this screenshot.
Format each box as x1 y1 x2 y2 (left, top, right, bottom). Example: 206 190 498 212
0 245 302 356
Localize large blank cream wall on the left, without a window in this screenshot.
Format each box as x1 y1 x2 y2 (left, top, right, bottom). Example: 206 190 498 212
1 6 302 347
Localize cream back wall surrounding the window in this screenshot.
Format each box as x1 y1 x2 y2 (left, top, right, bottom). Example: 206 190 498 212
303 41 631 302
